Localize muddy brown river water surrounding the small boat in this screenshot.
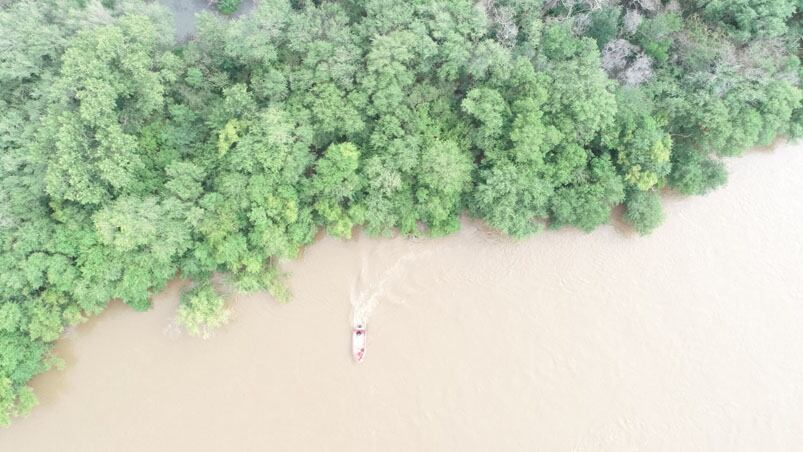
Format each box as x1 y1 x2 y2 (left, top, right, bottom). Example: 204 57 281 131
0 146 803 452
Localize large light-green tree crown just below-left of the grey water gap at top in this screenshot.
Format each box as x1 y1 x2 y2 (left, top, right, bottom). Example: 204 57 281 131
39 16 173 204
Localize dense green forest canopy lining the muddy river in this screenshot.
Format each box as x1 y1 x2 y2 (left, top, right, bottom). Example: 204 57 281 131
0 0 803 423
